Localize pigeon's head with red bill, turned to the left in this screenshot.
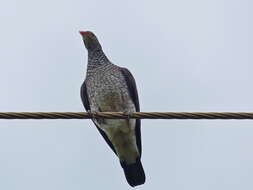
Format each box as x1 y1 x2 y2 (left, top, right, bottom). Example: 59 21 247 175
79 31 102 51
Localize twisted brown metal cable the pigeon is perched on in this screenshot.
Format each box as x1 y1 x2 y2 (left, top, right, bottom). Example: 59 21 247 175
0 112 253 119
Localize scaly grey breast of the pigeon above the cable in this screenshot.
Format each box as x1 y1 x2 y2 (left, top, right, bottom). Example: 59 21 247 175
86 65 132 112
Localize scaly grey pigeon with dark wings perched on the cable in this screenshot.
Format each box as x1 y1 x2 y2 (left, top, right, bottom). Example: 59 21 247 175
79 31 146 187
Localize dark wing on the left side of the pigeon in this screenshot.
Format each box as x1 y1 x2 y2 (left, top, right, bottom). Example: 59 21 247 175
81 82 116 154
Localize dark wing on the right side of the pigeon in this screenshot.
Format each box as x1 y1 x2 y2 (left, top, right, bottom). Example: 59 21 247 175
120 67 142 155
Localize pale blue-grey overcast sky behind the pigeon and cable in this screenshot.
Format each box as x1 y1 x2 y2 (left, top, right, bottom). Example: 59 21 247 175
0 0 253 190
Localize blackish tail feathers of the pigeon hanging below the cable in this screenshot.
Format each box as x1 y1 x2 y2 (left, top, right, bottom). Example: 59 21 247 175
120 159 146 187
